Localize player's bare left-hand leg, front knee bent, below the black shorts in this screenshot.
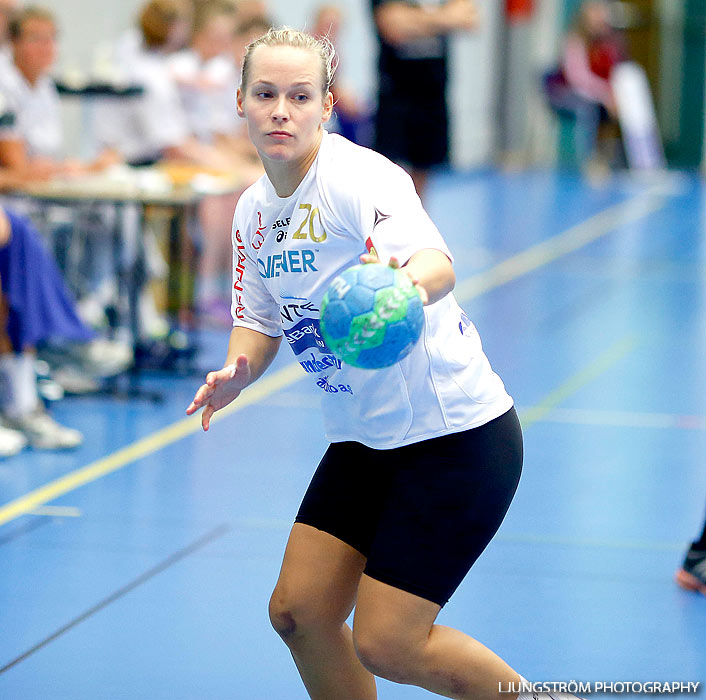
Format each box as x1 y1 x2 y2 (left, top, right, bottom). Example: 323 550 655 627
270 523 377 700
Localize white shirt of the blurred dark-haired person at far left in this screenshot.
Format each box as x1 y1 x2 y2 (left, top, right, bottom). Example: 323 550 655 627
0 60 64 158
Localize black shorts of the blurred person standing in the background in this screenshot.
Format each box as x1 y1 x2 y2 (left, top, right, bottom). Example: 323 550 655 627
374 88 449 170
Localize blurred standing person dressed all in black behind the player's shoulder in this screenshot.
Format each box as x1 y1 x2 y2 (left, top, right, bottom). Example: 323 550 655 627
371 0 477 198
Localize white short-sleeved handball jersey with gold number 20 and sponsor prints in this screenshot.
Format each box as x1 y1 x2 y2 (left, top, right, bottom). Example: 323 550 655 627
232 132 512 449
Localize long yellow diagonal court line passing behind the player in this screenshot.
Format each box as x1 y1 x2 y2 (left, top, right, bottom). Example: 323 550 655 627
0 187 666 525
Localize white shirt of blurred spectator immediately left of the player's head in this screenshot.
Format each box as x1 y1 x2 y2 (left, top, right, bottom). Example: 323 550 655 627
169 49 238 143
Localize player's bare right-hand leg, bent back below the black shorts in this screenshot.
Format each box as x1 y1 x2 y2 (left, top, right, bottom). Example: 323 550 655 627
353 575 520 700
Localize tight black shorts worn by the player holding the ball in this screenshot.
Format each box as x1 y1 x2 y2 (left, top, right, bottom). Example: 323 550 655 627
296 408 522 606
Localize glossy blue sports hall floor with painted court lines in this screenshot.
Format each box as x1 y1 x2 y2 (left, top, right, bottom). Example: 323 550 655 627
0 171 706 700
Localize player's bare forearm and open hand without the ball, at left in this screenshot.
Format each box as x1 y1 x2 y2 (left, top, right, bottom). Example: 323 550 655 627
186 327 282 430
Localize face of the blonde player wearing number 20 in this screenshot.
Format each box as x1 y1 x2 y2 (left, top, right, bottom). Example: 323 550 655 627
238 46 333 167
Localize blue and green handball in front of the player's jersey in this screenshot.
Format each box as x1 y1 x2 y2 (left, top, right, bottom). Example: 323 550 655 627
321 263 424 369
